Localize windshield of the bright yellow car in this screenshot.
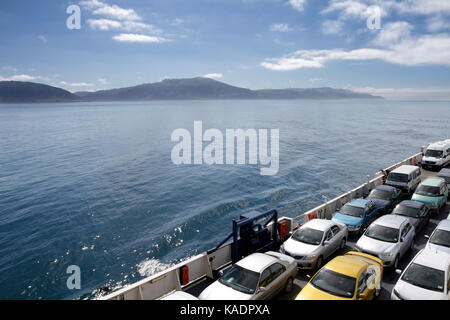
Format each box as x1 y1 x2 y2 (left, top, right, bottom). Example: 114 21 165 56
311 268 356 298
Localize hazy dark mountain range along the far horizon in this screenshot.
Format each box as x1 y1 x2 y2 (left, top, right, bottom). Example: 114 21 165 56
0 77 382 103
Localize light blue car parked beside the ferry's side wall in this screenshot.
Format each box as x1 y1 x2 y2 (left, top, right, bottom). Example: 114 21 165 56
332 199 380 235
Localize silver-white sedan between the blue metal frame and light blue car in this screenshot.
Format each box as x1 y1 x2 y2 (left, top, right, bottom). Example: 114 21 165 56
280 219 348 269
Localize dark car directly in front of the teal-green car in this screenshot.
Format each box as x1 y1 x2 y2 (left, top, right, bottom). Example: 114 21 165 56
392 200 431 233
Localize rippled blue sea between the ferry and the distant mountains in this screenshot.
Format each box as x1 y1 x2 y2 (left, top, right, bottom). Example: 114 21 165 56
0 100 450 299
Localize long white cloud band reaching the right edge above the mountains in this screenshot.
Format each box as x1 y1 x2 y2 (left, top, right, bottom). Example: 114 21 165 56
260 33 450 71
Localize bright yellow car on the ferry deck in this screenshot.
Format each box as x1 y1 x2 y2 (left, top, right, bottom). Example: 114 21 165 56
295 251 383 300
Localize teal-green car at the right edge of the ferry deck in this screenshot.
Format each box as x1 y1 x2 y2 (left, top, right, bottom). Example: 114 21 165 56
411 177 448 213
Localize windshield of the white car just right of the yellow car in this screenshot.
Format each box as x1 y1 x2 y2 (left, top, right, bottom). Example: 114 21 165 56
402 263 444 292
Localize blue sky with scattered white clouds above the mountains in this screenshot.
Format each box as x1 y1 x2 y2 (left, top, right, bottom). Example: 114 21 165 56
0 0 450 100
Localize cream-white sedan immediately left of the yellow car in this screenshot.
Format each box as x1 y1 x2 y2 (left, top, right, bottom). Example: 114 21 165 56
199 251 297 300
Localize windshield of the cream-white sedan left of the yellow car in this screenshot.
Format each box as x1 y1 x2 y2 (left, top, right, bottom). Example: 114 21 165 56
219 265 259 294
